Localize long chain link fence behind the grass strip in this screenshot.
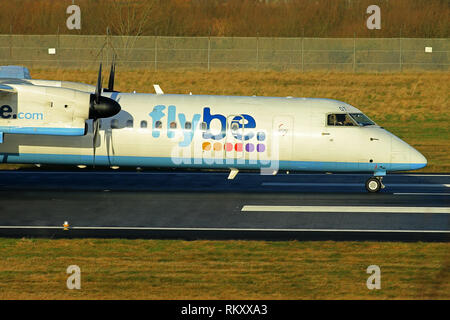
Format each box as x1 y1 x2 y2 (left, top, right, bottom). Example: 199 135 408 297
0 35 450 72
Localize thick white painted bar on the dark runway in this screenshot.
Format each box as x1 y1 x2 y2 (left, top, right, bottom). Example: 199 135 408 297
241 205 450 213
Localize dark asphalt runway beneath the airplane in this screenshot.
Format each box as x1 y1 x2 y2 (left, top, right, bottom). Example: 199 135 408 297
0 171 450 241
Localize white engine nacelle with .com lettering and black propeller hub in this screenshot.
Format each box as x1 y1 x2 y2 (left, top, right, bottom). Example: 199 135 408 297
0 83 120 140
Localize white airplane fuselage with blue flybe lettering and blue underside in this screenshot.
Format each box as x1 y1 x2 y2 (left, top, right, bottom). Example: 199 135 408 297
0 93 427 173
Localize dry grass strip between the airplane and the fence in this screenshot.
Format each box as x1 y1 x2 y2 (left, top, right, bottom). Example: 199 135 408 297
25 70 450 172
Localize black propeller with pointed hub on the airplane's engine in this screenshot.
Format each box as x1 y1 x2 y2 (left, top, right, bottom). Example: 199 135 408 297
89 62 121 168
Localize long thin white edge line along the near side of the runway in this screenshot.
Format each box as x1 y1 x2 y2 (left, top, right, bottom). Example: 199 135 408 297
0 226 450 234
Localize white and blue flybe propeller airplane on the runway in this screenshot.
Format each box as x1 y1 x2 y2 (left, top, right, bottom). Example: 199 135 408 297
0 62 427 193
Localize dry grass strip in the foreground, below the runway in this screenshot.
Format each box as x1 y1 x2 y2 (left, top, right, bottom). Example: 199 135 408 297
0 239 450 299
